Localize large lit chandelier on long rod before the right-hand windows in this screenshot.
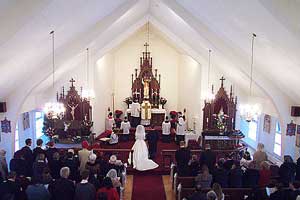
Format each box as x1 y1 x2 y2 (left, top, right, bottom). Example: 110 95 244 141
239 33 261 122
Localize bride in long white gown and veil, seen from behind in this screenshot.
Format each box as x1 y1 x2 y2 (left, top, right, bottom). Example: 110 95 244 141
128 125 158 171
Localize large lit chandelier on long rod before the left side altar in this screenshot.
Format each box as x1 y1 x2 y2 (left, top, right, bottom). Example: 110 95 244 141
44 31 66 119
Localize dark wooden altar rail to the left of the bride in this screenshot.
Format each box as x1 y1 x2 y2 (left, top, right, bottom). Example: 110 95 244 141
60 148 133 167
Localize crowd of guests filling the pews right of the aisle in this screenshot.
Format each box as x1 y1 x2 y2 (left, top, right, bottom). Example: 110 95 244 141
176 142 300 200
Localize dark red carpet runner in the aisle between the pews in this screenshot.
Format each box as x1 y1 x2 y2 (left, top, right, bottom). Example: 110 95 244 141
132 175 166 200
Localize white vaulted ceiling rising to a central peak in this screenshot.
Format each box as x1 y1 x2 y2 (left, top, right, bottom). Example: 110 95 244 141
0 0 300 111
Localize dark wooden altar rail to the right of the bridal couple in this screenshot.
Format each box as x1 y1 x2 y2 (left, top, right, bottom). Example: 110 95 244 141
161 147 245 168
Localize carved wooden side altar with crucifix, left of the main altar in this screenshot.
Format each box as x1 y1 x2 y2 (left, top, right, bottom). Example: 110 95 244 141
43 78 93 140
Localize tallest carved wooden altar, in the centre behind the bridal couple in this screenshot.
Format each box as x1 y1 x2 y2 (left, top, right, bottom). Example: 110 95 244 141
127 43 167 126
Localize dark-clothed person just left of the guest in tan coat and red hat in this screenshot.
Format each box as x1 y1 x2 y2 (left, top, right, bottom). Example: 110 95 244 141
62 149 79 181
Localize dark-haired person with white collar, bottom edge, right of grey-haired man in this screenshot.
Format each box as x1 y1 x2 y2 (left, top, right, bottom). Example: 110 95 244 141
74 170 96 200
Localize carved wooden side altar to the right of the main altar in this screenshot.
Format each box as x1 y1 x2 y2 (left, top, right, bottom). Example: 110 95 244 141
202 77 243 149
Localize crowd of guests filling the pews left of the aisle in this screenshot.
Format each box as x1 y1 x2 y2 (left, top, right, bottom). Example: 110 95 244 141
0 139 125 200
